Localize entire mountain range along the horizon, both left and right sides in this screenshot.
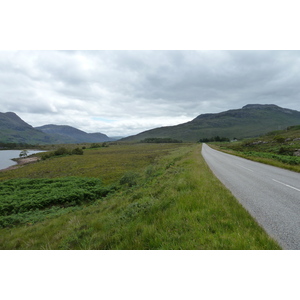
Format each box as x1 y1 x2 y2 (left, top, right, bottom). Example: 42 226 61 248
0 104 300 144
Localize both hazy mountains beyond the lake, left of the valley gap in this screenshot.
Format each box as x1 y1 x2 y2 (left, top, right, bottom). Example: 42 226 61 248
0 112 115 145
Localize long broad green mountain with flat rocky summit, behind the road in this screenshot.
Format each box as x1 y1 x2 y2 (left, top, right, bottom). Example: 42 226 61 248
122 104 300 142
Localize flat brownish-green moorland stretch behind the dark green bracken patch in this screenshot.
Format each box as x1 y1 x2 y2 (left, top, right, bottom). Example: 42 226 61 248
0 144 181 184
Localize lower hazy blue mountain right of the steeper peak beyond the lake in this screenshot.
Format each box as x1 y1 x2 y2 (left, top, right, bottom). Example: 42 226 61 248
35 124 112 144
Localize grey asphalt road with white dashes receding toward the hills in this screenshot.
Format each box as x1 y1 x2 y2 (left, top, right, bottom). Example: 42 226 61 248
202 144 300 249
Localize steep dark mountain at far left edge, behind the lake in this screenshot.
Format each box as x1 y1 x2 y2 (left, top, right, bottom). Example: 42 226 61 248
0 112 55 144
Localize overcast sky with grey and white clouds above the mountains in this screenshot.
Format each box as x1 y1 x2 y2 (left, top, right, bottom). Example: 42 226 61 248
0 51 300 136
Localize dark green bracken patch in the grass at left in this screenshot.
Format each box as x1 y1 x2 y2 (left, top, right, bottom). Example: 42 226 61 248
0 177 114 227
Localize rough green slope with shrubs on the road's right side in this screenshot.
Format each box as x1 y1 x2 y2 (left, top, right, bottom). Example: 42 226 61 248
211 125 300 172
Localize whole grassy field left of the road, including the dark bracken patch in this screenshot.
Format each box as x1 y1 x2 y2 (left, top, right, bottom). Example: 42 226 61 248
0 143 280 249
